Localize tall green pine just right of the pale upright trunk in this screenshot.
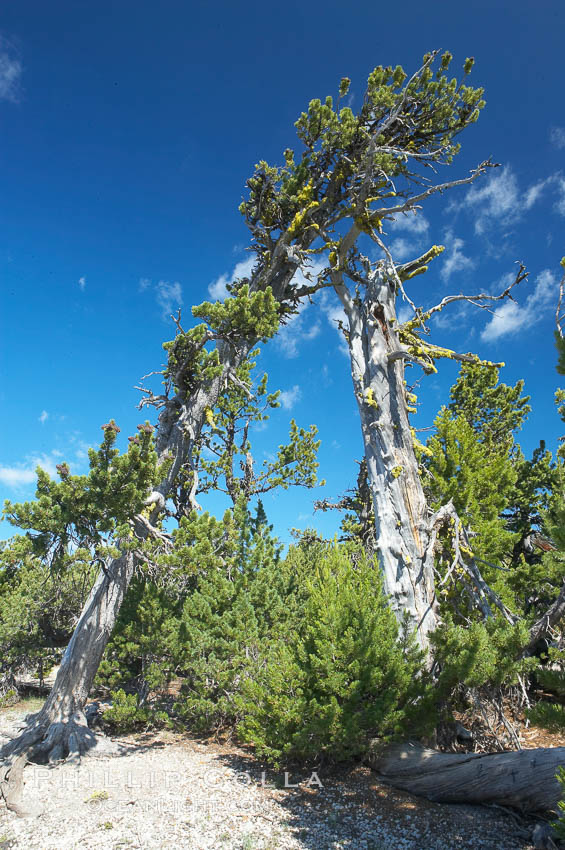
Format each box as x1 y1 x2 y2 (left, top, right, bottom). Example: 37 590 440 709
422 364 559 620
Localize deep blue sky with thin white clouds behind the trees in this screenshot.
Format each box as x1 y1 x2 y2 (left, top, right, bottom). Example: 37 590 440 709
0 0 565 541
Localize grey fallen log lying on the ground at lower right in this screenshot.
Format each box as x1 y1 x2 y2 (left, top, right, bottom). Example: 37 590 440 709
366 744 565 812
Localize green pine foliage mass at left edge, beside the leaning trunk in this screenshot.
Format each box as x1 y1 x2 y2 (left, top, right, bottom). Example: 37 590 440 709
0 420 158 682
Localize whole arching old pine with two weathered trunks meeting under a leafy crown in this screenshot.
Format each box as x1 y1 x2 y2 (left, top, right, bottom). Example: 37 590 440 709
4 52 560 804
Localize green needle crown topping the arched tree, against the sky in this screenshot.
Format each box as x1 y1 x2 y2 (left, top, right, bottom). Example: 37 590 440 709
240 52 485 253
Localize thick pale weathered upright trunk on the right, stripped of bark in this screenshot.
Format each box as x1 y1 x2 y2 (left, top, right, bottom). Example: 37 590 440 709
336 266 436 650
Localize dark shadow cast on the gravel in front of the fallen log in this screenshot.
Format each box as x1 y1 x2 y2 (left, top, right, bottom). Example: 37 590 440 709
212 746 535 850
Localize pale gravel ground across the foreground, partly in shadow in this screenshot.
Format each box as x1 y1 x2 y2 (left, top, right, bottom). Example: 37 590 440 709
0 718 532 850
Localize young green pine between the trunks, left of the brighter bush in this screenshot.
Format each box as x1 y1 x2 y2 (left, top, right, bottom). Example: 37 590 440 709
167 503 292 732
